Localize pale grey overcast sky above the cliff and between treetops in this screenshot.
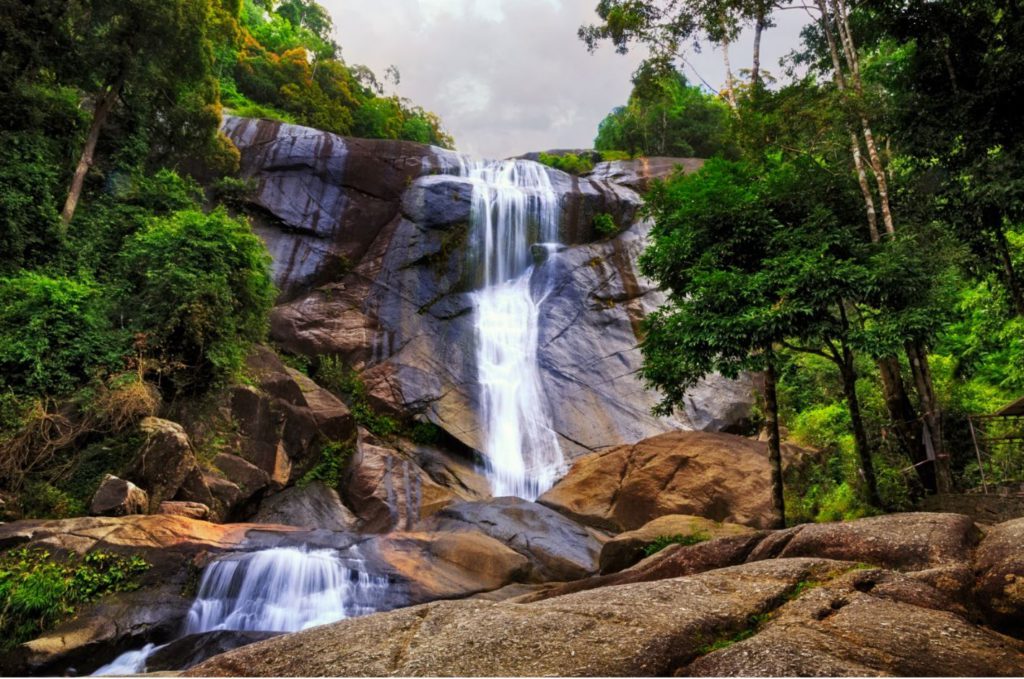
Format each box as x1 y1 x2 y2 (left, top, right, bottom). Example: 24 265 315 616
321 0 807 158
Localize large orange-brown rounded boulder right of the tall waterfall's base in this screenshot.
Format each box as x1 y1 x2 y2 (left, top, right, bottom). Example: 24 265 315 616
539 431 794 532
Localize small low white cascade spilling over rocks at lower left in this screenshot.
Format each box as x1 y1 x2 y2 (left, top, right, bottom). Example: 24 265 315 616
94 547 388 675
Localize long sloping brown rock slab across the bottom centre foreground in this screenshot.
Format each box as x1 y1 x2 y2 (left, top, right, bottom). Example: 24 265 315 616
186 559 838 676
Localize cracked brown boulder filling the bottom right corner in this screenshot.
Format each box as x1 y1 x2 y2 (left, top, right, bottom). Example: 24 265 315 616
682 570 1024 677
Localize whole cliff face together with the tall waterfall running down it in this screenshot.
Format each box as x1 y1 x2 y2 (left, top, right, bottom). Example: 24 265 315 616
224 118 753 477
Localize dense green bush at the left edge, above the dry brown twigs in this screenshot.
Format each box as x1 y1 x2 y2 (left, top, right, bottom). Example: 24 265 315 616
0 271 129 395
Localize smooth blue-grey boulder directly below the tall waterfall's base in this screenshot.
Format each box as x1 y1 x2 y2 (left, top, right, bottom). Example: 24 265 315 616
419 498 601 580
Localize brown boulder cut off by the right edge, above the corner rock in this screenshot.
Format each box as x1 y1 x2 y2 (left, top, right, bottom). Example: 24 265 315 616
975 518 1024 635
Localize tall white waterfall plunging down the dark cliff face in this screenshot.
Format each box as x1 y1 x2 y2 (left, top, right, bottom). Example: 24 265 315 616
460 160 565 500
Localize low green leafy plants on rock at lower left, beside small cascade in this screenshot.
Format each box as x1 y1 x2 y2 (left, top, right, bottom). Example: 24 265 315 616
0 548 150 652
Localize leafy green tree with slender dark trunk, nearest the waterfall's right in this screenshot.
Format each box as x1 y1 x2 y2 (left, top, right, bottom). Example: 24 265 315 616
640 161 797 527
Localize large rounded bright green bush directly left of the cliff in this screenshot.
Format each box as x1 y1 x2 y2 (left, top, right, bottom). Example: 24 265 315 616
121 209 274 390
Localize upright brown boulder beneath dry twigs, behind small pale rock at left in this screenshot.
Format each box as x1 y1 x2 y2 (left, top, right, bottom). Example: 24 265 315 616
127 417 198 512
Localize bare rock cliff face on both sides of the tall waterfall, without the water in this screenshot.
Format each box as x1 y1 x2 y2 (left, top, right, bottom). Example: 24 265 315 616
224 118 751 467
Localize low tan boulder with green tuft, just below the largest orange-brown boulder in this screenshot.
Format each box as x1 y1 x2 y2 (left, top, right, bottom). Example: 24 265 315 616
600 514 754 574
